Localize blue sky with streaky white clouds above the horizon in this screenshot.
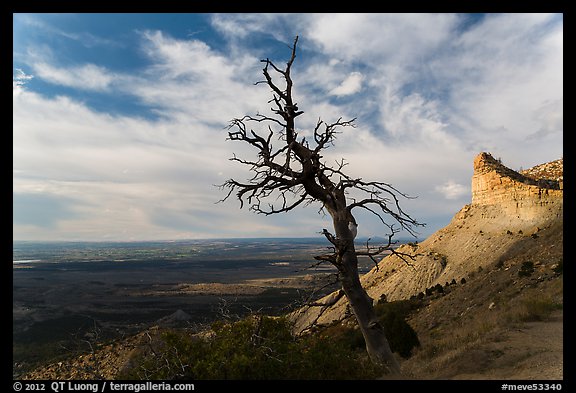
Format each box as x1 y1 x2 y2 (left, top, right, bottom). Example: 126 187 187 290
13 14 563 241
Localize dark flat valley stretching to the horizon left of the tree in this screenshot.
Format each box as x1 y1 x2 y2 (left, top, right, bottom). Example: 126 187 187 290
12 238 382 374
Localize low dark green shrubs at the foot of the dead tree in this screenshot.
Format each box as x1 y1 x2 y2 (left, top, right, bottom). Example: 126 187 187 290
120 316 378 380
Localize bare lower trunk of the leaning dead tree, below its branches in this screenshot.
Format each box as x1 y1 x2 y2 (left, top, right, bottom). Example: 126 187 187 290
334 220 400 375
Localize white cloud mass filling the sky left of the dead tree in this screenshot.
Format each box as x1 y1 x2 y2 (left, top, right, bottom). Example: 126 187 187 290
13 27 278 239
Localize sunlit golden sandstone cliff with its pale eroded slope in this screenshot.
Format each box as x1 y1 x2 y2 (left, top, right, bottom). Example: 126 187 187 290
294 153 563 331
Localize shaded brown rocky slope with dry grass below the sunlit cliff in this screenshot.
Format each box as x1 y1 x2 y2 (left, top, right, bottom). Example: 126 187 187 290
402 214 564 380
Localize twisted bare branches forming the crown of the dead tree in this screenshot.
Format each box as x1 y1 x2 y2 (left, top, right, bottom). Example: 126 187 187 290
220 33 423 267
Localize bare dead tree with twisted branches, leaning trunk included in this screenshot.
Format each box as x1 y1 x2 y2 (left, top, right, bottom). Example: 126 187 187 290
221 37 422 374
